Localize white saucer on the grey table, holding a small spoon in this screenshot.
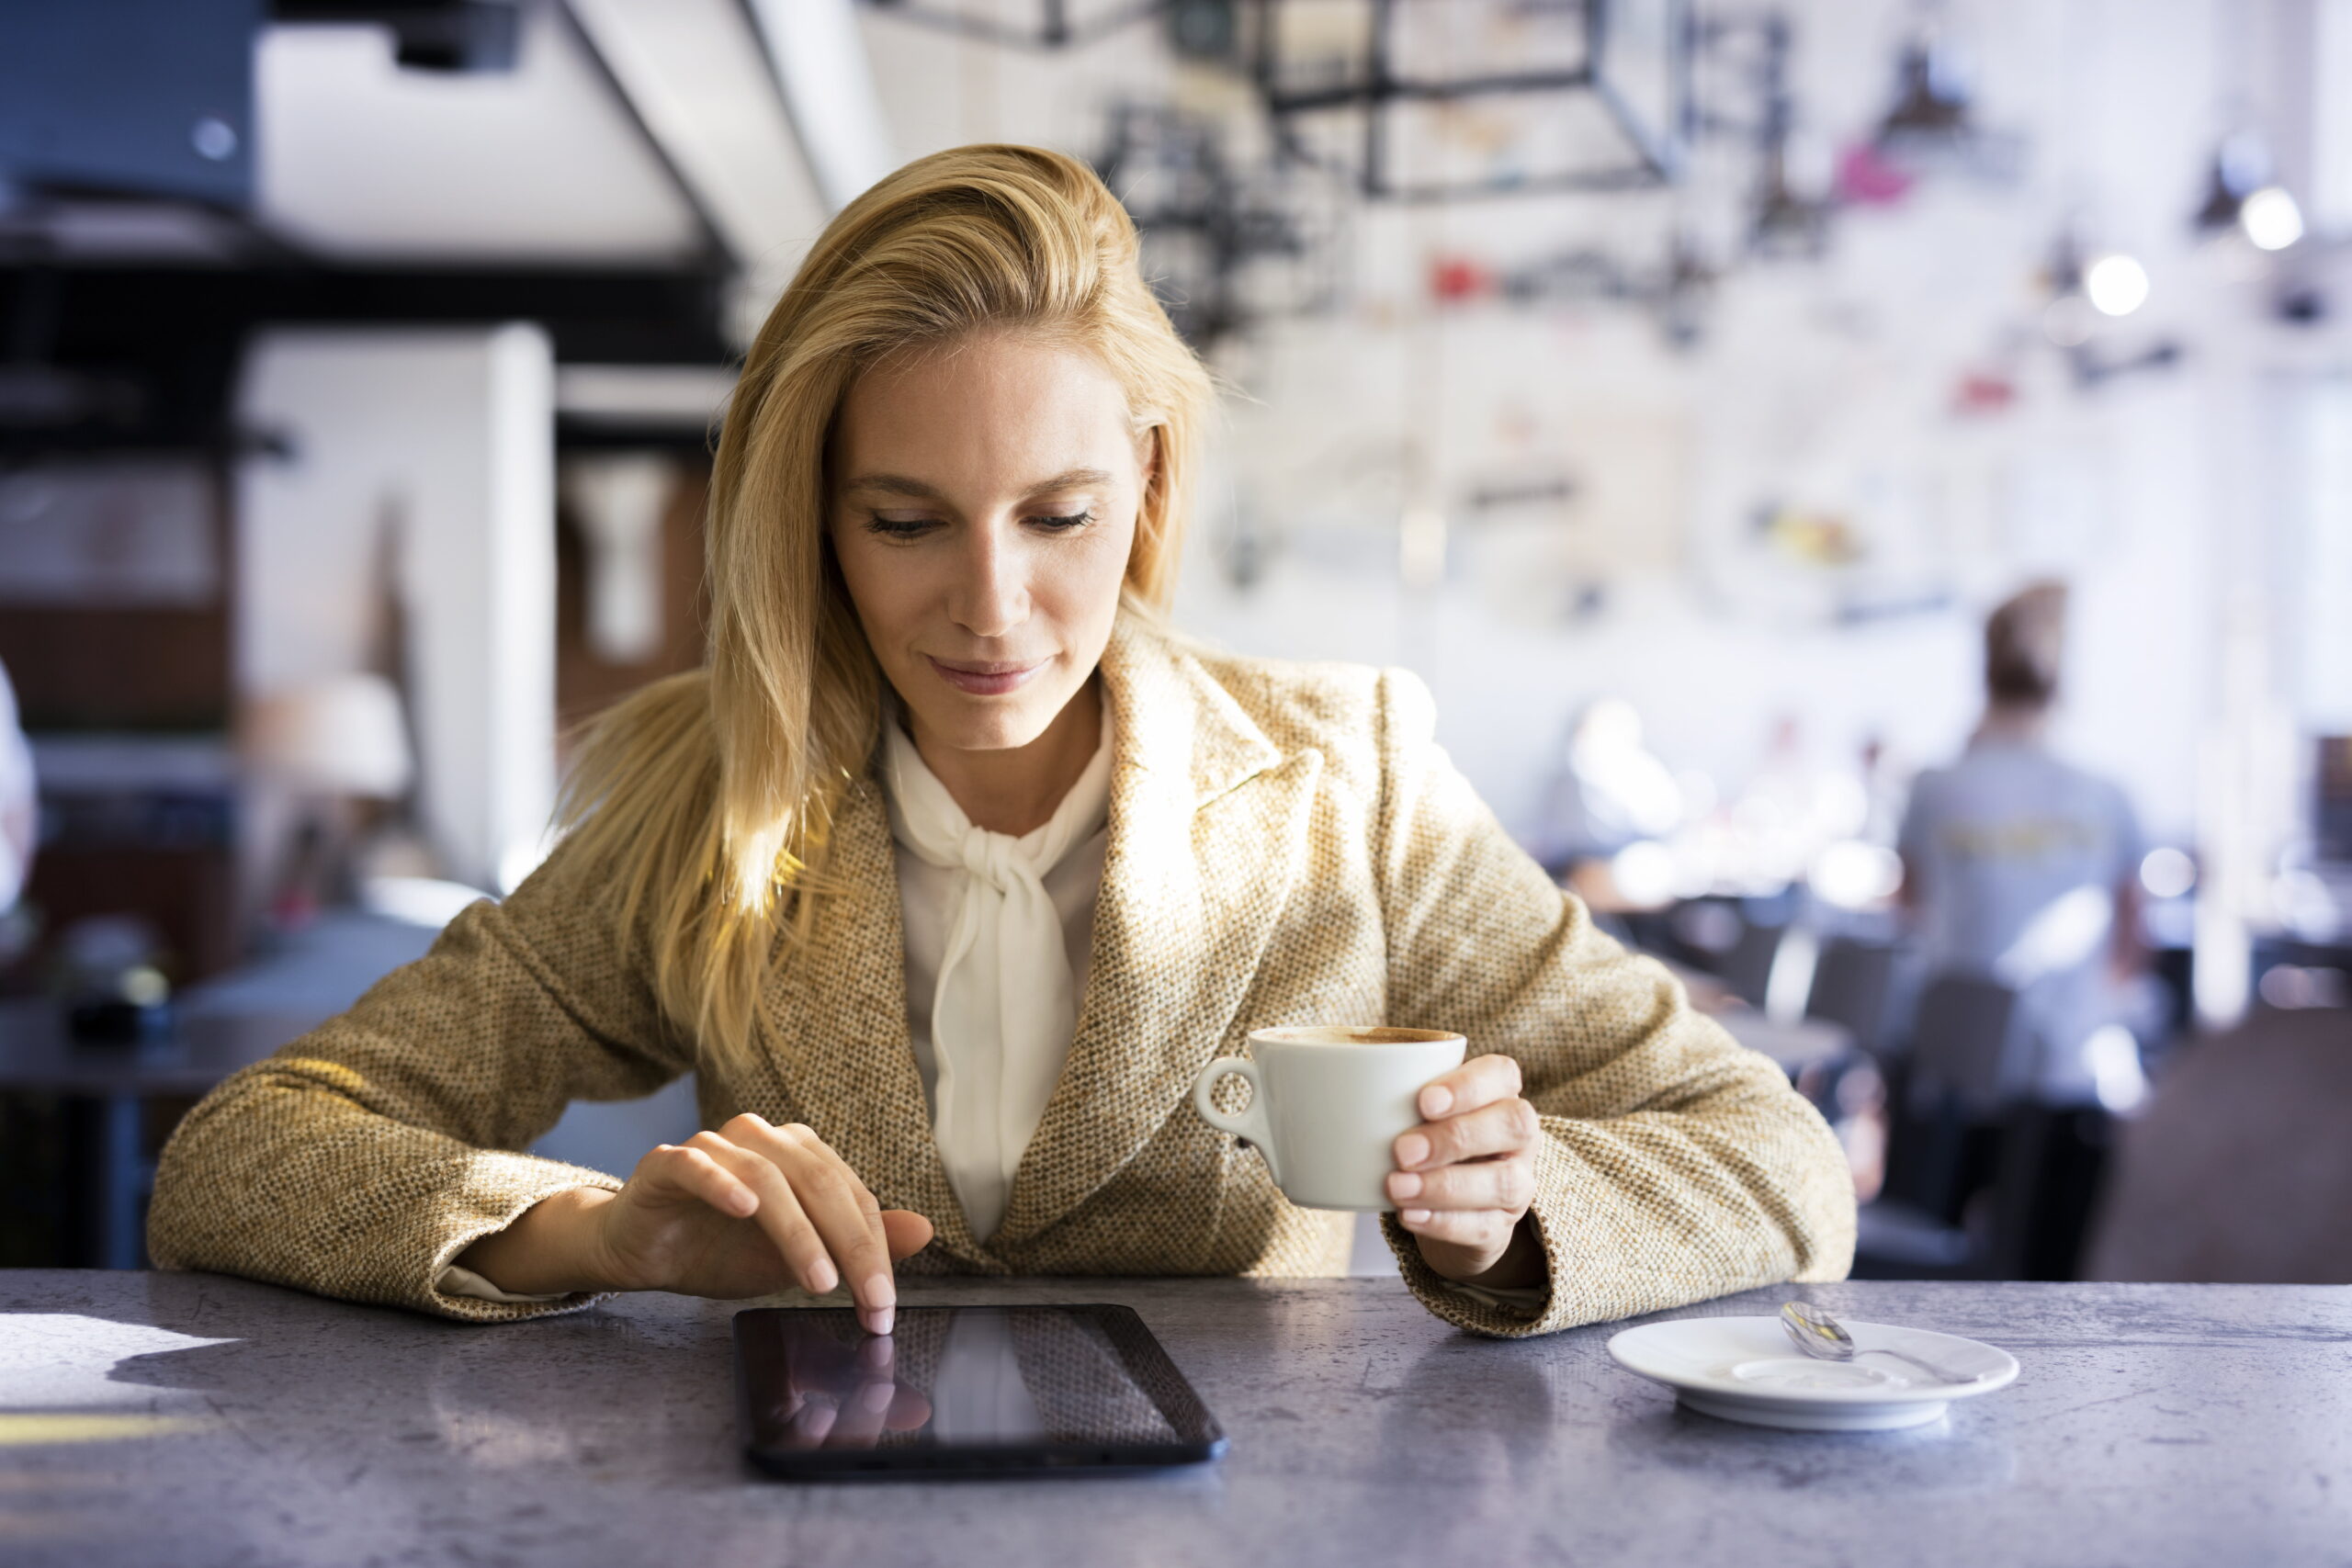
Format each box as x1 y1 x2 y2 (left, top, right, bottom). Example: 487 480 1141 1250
1609 1316 2018 1432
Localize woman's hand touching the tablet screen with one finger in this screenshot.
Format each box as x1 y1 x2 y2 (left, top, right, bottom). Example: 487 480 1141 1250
458 1112 932 1333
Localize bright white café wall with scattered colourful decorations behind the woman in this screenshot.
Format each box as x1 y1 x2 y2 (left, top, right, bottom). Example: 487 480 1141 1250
865 0 2352 860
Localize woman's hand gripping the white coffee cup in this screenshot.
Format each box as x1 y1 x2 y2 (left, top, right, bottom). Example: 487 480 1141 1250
1387 1055 1545 1288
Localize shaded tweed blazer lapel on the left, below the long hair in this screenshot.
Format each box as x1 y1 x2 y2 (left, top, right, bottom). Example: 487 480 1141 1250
764 776 1004 1272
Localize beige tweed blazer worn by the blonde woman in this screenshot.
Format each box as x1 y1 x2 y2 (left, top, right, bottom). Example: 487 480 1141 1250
148 618 1853 1336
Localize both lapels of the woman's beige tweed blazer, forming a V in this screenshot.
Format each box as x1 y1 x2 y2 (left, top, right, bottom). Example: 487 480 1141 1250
767 618 1322 1274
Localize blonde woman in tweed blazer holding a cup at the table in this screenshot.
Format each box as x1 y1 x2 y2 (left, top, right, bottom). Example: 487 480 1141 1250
151 146 1853 1336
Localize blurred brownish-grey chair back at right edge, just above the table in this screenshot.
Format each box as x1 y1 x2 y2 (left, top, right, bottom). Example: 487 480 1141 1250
2084 1009 2352 1283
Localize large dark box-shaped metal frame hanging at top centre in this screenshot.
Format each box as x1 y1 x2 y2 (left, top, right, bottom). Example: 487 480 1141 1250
1249 0 1693 202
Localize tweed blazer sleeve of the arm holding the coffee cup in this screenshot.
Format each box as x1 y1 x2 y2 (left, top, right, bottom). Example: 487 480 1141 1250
1376 672 1853 1336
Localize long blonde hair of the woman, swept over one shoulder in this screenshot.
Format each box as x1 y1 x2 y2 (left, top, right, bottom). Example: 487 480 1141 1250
558 146 1211 1081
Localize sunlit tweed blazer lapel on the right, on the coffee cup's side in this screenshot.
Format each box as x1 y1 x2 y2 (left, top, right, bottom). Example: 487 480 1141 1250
990 618 1322 1253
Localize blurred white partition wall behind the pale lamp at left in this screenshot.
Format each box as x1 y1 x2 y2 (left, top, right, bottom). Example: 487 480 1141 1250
235 324 555 891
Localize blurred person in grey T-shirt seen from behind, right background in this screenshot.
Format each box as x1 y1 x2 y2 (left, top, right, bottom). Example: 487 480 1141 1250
1898 583 2147 1277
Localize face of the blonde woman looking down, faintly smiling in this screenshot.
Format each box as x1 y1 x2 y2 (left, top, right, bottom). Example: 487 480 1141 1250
831 332 1148 752
